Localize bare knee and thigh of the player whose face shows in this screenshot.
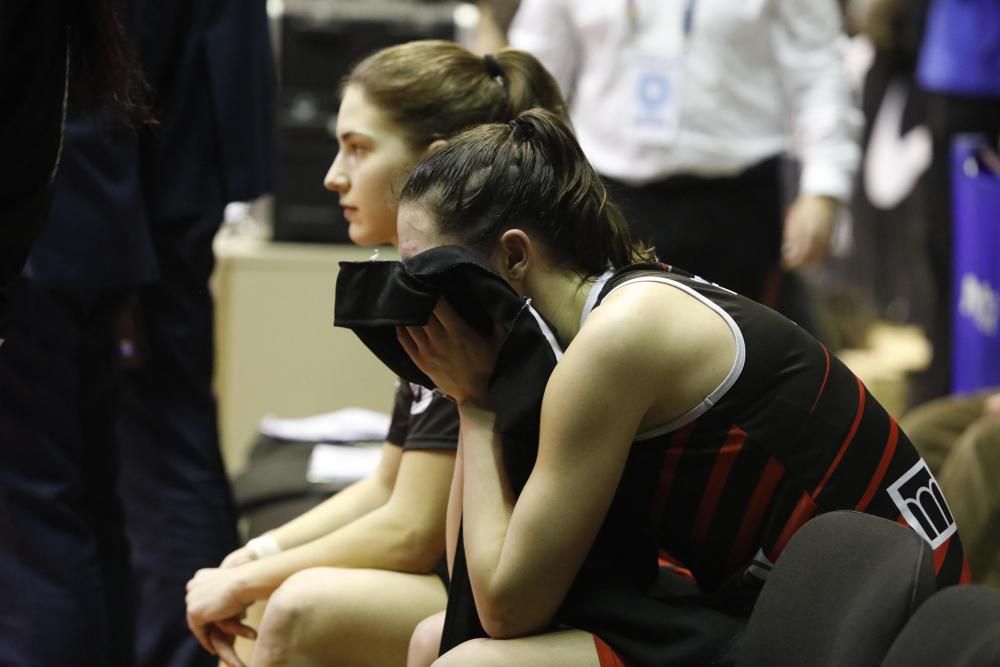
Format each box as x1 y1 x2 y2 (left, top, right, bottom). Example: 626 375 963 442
250 568 447 667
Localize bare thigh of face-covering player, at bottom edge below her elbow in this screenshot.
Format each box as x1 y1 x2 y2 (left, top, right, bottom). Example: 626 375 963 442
433 630 600 667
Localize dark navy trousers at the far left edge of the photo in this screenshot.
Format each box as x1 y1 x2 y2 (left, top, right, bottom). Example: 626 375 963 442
0 279 133 667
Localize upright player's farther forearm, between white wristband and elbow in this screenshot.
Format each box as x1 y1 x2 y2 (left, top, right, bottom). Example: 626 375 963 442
268 475 392 551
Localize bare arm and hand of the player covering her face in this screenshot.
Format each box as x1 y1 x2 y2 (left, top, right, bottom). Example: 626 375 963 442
403 285 735 638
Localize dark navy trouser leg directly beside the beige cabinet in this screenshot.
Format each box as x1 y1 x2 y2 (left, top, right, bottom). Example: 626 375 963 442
118 210 237 667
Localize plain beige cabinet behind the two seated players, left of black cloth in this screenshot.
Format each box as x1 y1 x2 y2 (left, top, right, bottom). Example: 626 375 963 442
213 235 396 472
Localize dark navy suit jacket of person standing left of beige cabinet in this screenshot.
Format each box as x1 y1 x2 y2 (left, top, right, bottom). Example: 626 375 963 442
28 0 275 288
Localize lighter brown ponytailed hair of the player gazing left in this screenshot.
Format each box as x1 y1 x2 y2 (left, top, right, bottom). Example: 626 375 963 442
341 40 568 149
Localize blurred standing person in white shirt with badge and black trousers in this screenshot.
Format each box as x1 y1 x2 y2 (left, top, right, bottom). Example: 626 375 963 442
509 0 860 324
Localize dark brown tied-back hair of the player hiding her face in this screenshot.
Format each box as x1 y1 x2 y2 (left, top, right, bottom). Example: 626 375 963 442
400 109 653 276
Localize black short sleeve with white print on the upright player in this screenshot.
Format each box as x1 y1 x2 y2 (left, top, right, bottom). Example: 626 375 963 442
385 378 458 452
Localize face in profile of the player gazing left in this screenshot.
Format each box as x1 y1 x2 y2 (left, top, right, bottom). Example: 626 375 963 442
323 86 418 245
